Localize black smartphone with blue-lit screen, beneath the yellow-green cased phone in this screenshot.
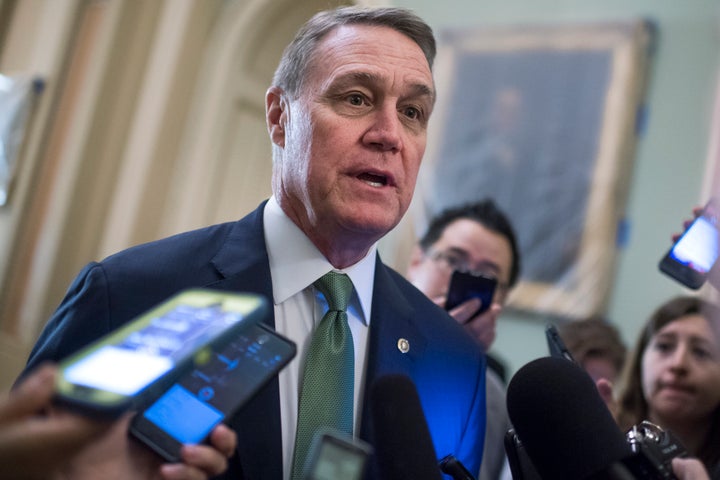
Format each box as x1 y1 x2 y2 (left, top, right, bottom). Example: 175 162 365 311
130 324 296 462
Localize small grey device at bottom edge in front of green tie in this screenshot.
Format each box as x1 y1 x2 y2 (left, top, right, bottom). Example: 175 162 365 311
303 429 372 480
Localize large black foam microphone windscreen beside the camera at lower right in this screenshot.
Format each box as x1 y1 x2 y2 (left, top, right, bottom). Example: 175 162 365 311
507 357 632 480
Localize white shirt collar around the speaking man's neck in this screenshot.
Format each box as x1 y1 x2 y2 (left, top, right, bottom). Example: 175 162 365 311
263 196 377 325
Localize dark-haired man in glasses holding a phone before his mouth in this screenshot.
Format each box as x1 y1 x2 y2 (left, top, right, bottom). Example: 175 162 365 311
407 199 520 480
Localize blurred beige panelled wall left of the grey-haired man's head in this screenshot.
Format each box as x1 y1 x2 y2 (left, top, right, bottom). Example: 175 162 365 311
0 0 345 388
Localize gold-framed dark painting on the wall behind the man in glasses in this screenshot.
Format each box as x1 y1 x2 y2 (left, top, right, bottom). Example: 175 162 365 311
412 19 655 319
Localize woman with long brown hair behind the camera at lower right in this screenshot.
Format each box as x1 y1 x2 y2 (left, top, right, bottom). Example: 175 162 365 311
618 296 720 480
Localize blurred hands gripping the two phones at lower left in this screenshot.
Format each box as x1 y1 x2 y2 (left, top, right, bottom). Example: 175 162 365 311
0 365 237 480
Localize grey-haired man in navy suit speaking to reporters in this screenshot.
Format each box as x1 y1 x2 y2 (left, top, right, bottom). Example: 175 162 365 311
19 7 485 480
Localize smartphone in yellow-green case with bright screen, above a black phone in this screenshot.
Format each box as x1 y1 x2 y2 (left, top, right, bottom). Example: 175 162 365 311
55 289 269 416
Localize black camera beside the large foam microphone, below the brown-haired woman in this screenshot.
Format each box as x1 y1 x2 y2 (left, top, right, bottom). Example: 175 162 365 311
625 420 687 480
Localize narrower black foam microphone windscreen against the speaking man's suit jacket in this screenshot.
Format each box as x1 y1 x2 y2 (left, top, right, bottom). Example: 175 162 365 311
370 374 441 480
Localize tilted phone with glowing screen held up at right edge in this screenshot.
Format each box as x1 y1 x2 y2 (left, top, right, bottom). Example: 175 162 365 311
659 199 718 290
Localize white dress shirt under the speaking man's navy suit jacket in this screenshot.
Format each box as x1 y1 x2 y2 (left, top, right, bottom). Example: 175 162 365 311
263 197 377 480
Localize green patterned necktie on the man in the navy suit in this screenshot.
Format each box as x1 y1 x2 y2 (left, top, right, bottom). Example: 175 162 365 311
292 272 355 480
